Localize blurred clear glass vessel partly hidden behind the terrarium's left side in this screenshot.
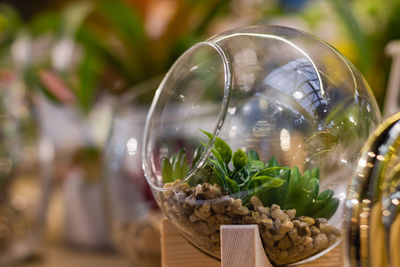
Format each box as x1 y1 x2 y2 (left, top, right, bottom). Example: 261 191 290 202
104 78 162 267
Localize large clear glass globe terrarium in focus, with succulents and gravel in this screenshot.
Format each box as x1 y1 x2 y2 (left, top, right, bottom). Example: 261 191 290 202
143 26 380 265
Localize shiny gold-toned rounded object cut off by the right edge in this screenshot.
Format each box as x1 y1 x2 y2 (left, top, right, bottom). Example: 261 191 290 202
344 114 400 266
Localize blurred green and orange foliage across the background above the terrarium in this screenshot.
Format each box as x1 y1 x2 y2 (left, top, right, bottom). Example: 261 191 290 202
0 0 400 110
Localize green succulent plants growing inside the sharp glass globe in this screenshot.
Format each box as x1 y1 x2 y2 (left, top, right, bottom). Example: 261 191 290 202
161 131 339 219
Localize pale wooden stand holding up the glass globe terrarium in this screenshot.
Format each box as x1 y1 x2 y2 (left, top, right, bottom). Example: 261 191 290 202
161 219 343 267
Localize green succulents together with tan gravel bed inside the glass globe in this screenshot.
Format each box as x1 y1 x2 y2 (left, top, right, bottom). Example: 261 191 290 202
157 132 340 265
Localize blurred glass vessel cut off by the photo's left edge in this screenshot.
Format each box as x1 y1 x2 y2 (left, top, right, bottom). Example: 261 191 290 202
0 68 51 266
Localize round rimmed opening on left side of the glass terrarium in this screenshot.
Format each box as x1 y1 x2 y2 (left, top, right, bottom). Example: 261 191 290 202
143 42 231 190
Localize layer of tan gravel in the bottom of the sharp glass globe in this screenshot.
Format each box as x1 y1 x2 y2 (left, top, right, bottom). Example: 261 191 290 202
157 180 340 265
